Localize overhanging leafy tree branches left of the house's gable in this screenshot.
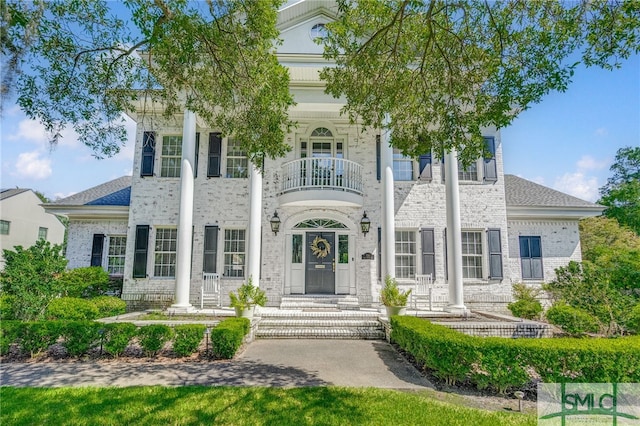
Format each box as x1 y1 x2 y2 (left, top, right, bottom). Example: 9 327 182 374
2 0 293 166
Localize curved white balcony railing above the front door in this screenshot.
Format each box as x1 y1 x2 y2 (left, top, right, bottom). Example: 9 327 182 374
282 158 362 195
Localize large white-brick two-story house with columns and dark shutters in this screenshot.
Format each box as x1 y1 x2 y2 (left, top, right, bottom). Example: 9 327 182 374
42 1 602 310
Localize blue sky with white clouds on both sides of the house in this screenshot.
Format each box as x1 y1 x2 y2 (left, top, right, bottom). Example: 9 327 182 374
0 55 640 201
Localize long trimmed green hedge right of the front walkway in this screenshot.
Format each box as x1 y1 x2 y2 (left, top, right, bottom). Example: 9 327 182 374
391 316 640 392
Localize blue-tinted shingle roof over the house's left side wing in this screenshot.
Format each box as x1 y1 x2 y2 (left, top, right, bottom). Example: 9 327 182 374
49 176 131 206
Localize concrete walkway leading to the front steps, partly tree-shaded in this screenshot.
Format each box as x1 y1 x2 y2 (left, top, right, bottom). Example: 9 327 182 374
0 339 433 389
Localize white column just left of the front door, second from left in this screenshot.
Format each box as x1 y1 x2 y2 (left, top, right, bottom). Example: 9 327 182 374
247 163 262 287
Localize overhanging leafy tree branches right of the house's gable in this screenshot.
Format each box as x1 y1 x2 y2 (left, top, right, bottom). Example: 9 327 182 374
321 0 640 163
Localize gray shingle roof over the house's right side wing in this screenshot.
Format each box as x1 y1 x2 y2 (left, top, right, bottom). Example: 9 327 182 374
504 175 599 207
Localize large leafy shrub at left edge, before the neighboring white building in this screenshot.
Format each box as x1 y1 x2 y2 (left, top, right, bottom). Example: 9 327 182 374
0 240 67 321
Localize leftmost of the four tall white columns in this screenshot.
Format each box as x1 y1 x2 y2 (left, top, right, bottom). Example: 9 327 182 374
171 110 196 311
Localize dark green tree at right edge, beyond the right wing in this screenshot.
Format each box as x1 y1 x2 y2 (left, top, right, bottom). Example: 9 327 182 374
598 147 640 235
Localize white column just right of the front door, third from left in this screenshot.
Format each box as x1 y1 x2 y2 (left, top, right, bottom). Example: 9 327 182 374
380 116 396 280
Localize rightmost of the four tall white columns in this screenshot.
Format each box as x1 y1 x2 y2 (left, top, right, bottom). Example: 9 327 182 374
444 149 466 312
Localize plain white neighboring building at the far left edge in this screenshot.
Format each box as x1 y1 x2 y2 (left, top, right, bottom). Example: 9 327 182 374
0 188 65 269
